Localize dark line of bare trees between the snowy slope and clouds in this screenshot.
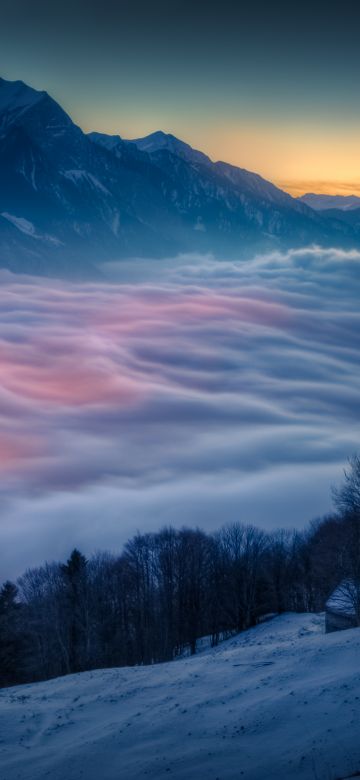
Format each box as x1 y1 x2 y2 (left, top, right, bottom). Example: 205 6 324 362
0 456 360 686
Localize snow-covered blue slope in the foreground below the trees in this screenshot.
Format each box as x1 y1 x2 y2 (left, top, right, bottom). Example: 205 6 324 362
0 615 360 780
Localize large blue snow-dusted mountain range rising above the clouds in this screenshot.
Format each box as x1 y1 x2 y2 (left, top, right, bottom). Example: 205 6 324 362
0 79 360 276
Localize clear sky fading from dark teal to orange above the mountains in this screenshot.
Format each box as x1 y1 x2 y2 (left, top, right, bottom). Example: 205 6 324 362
0 0 360 194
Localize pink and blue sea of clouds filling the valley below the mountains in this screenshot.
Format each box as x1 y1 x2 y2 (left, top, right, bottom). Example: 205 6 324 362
0 248 360 580
